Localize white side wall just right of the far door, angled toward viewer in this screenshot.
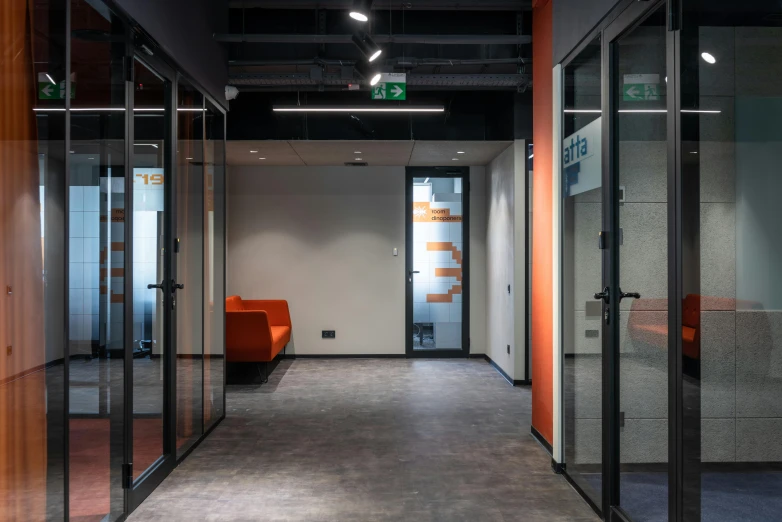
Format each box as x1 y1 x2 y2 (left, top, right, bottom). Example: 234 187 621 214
486 141 526 380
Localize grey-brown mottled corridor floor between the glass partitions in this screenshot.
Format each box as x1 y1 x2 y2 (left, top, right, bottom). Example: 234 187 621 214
129 359 597 522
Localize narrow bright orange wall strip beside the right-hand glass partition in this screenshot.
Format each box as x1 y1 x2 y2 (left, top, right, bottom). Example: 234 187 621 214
532 0 554 444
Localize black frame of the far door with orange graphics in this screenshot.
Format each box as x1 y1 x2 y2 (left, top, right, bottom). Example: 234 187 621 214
405 167 470 358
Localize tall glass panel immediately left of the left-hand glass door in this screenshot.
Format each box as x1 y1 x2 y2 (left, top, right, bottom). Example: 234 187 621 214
68 0 127 520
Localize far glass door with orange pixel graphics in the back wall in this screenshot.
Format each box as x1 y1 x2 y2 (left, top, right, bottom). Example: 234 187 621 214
405 168 470 357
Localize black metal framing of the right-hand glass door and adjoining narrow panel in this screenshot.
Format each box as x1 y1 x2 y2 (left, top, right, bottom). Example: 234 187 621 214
560 0 684 522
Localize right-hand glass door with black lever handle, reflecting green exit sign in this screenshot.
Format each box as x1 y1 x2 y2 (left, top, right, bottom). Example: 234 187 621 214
604 2 670 521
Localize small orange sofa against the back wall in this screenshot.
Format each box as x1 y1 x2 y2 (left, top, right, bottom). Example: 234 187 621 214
225 295 291 370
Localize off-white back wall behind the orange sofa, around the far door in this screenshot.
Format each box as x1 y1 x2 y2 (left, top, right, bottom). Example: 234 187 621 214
227 167 485 355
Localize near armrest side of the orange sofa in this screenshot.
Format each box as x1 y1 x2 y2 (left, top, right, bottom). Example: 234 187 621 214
225 310 272 362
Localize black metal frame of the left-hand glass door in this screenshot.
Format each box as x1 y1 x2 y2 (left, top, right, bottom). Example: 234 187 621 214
123 38 177 514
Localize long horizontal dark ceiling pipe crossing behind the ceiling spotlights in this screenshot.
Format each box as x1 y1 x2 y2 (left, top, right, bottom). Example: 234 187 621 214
214 33 532 45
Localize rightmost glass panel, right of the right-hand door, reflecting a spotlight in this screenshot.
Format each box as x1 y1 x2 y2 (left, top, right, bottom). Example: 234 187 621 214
680 0 782 521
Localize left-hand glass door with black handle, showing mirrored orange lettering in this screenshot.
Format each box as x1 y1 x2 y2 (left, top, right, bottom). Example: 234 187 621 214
126 50 176 510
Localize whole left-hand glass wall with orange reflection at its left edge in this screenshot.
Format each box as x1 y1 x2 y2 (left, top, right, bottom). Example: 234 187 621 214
0 0 225 522
